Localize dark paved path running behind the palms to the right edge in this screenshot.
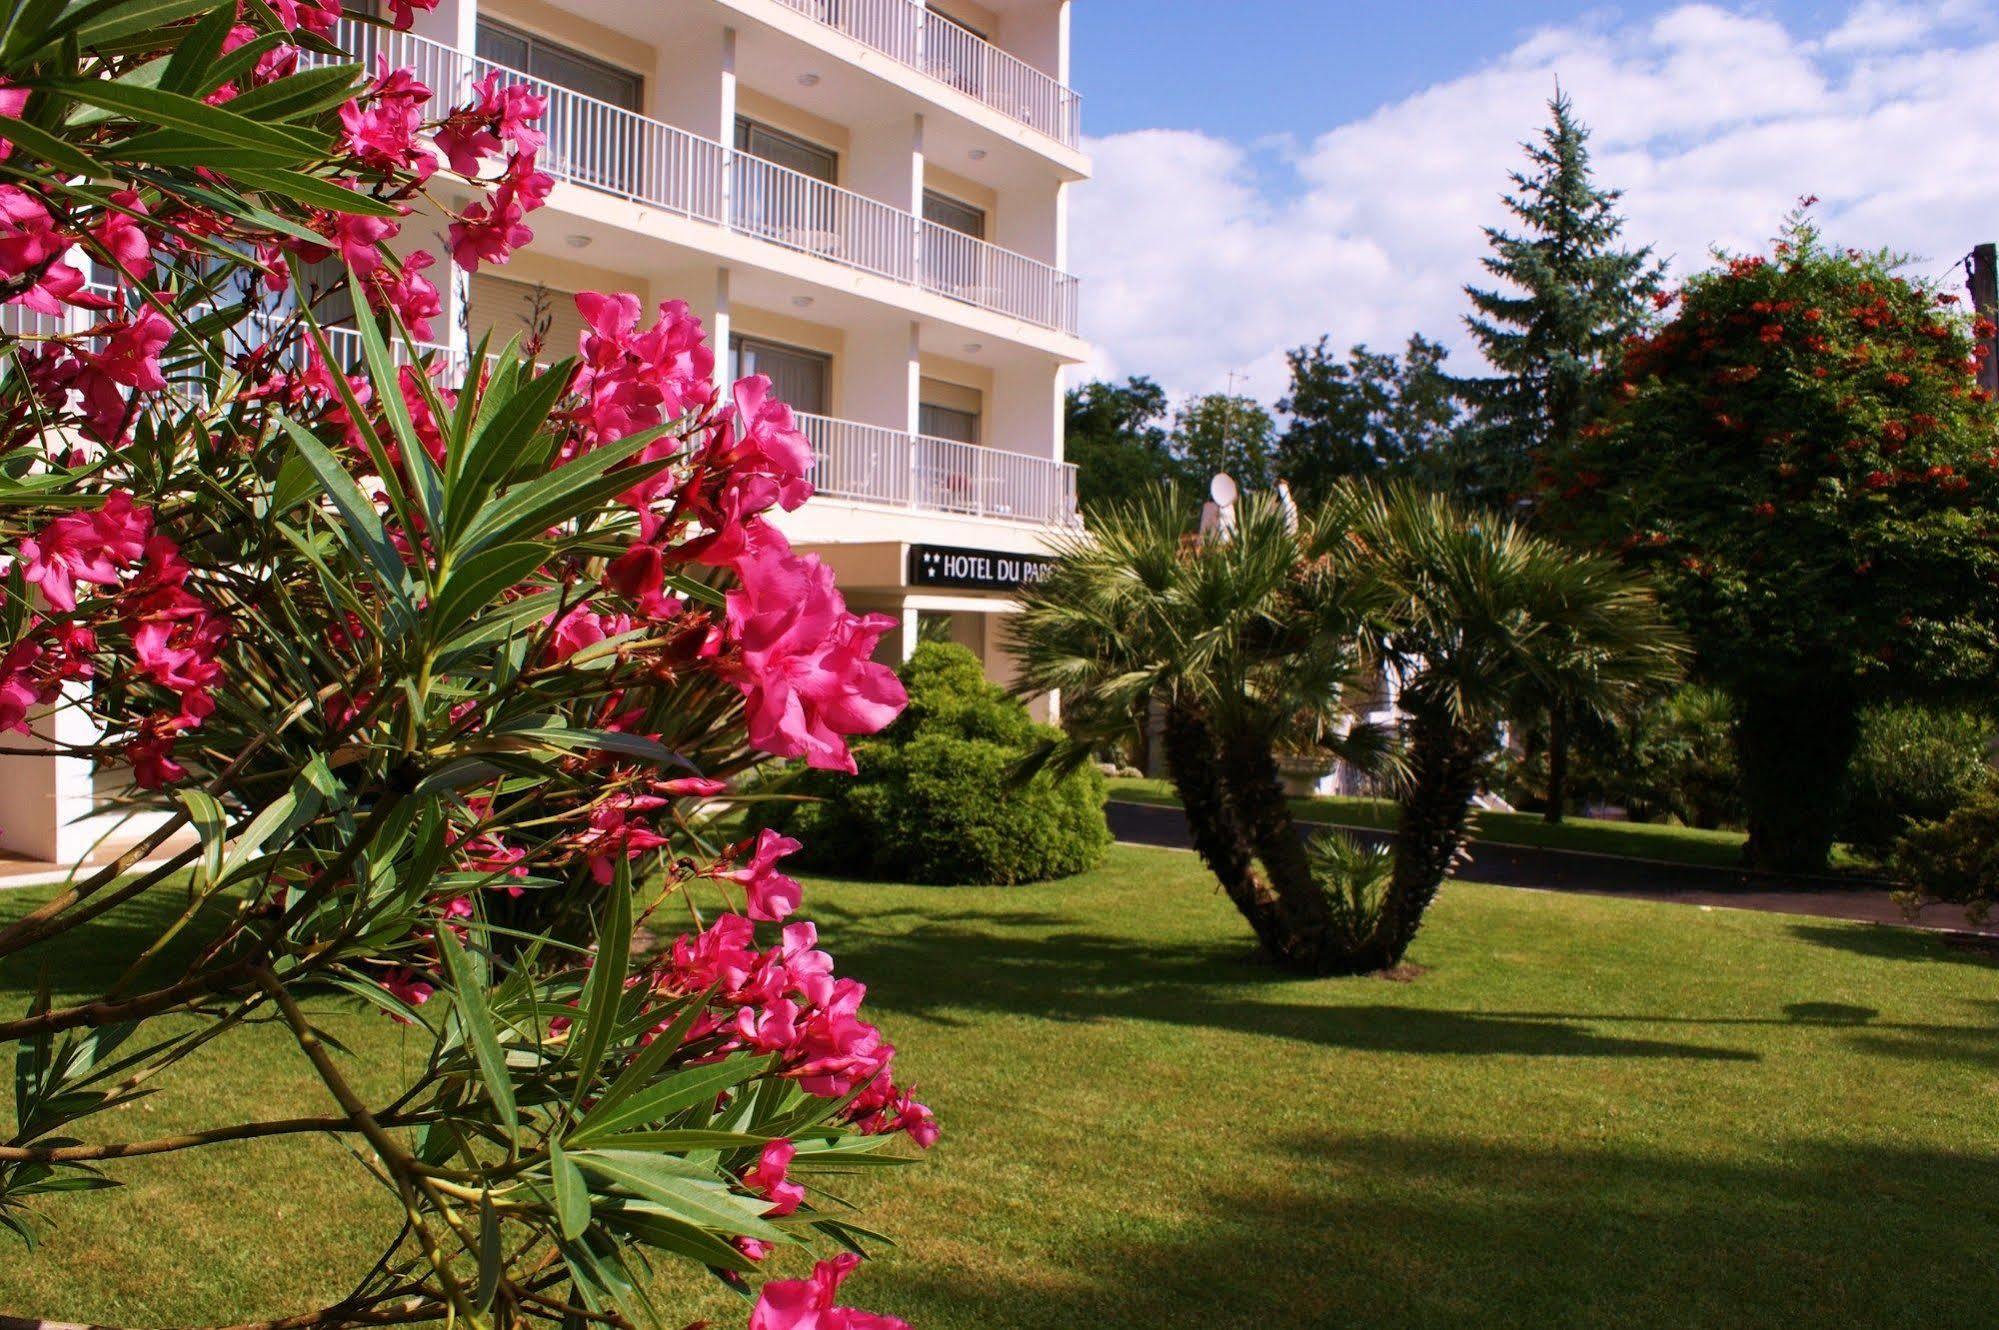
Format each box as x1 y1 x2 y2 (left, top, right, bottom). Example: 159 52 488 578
1107 802 1999 936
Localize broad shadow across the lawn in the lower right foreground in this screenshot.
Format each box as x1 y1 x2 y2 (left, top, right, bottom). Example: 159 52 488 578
876 1134 1999 1330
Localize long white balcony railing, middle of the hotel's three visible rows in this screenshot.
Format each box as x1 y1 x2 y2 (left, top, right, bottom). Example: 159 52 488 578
319 21 1075 334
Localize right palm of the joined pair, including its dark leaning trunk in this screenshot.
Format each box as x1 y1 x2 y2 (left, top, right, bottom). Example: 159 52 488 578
1325 484 1683 972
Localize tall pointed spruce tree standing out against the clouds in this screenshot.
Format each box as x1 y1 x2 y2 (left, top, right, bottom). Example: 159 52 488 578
1457 90 1665 504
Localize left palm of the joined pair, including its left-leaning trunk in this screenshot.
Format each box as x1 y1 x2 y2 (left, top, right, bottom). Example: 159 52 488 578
1013 486 1381 974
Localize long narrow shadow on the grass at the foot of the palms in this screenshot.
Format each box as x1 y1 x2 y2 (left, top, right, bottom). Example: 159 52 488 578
814 900 1757 1062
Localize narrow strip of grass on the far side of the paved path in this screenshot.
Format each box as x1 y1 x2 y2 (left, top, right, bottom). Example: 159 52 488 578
1109 778 1873 870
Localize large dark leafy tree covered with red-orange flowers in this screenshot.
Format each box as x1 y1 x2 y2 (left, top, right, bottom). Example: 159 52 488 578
1549 214 1999 870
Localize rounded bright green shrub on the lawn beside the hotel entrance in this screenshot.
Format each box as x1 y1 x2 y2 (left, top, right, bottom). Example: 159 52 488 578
762 642 1111 886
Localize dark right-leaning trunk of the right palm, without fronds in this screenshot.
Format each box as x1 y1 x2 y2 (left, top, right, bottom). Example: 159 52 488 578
1365 710 1491 970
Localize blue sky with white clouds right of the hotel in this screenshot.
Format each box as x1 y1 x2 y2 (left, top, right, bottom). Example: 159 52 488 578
1069 0 1999 400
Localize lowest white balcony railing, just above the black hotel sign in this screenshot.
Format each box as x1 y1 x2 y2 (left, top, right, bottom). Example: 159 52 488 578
798 412 1077 526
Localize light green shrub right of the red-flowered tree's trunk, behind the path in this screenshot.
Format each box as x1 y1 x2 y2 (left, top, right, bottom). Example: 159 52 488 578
1845 704 1999 850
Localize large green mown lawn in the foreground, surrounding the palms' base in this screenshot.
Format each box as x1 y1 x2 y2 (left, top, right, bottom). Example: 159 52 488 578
0 848 1999 1330
